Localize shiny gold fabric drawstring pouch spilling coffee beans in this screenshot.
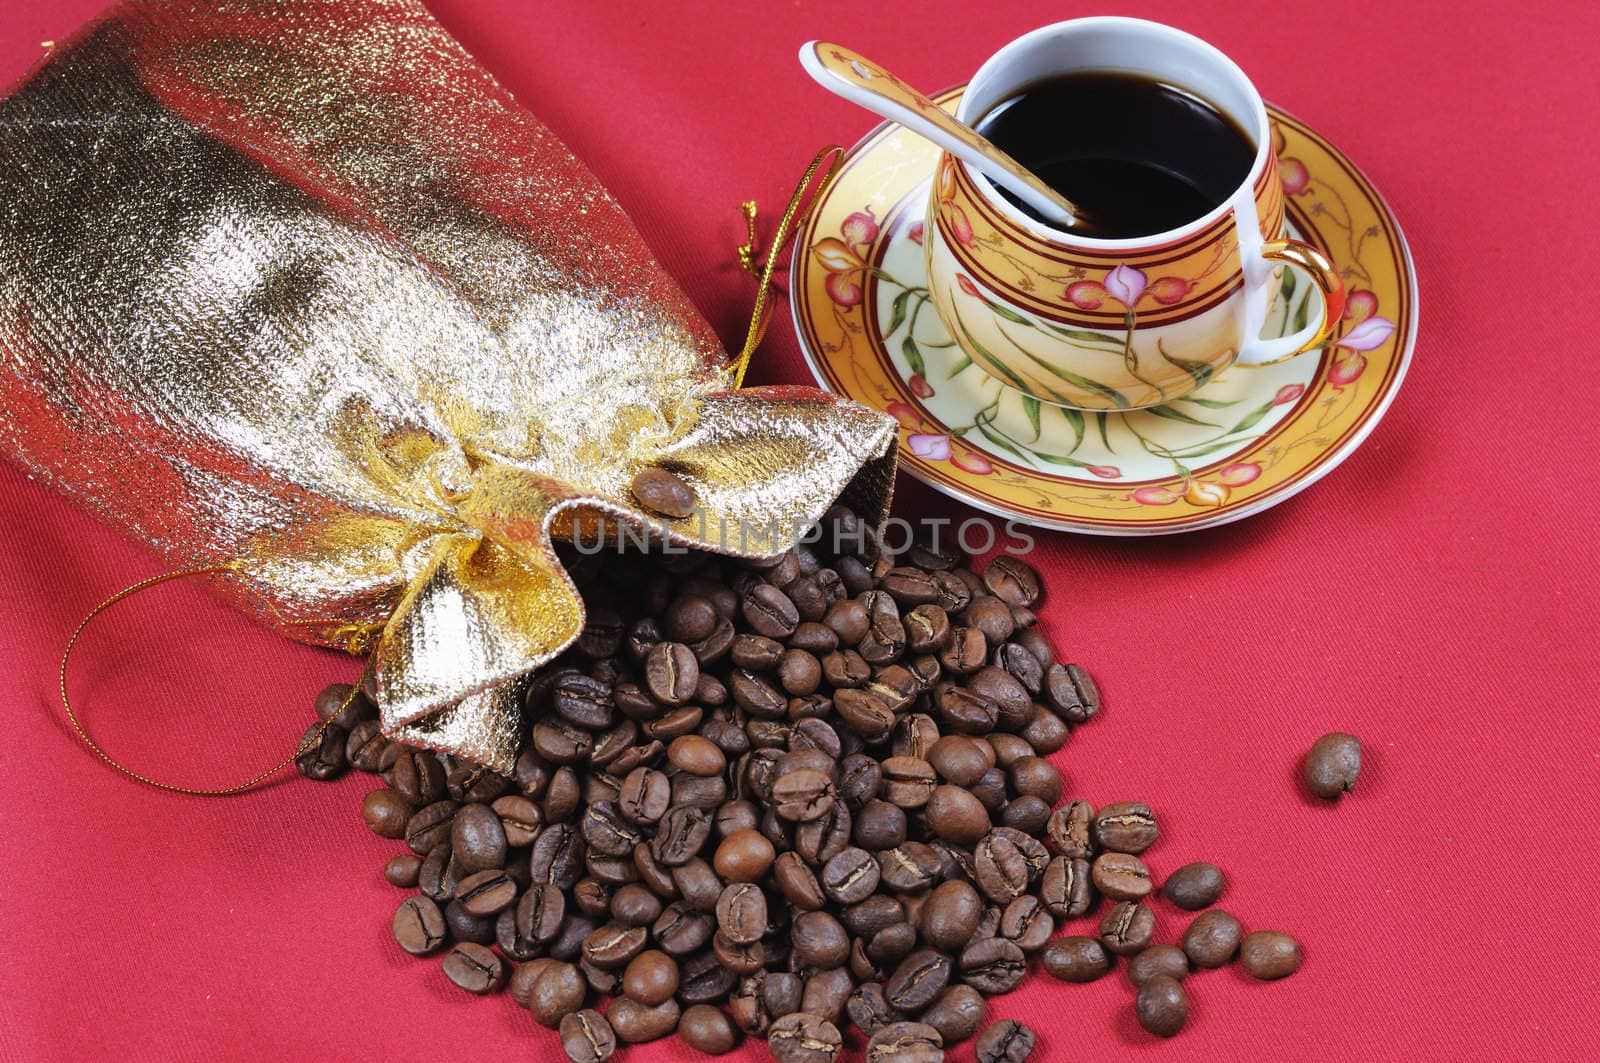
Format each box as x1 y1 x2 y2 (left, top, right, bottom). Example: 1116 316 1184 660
0 0 894 770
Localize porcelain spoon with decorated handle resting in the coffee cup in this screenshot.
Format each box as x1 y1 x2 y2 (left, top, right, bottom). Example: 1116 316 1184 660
800 40 1083 226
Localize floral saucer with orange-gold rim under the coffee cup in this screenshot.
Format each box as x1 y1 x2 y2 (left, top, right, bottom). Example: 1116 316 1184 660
789 86 1416 535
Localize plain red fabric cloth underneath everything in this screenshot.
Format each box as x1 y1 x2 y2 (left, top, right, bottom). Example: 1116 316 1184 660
0 0 1600 1060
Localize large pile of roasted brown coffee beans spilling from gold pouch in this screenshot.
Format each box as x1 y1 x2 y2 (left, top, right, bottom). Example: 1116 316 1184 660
298 507 1299 1063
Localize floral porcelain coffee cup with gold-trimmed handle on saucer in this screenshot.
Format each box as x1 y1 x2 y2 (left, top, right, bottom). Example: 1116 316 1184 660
923 18 1344 410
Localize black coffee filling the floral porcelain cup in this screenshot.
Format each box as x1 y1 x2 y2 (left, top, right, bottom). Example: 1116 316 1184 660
976 70 1256 240
